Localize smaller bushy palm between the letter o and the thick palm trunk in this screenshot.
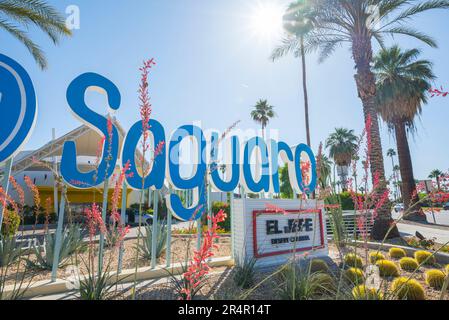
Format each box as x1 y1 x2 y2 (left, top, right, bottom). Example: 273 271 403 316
326 128 357 191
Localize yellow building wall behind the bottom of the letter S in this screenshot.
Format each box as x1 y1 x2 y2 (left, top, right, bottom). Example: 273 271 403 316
38 187 132 211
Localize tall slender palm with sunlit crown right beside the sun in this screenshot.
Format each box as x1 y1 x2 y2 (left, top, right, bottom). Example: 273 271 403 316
271 0 315 147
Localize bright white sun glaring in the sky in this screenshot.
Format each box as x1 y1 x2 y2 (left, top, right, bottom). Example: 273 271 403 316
250 1 284 41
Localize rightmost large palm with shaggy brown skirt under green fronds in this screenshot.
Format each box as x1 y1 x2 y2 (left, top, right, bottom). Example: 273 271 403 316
373 46 435 221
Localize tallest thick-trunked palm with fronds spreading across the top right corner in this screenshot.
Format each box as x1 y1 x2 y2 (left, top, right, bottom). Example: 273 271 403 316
306 0 449 239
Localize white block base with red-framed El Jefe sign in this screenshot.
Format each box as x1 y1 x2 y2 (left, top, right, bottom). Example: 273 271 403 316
232 199 329 268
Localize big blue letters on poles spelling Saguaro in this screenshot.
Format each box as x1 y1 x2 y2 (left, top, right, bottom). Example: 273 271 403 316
61 73 317 221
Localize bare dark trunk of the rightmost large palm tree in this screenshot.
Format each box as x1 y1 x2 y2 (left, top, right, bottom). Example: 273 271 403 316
394 122 427 222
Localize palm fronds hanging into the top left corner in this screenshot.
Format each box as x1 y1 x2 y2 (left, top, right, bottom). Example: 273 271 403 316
0 0 71 69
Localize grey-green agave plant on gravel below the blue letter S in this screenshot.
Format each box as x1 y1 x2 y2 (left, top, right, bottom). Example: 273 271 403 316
27 225 87 270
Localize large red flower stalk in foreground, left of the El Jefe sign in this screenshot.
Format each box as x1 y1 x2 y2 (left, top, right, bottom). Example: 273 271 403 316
181 210 226 300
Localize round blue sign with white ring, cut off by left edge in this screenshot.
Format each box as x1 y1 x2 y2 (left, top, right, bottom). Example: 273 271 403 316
0 54 37 163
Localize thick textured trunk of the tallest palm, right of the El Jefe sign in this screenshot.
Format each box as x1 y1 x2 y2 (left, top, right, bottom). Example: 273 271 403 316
352 33 399 240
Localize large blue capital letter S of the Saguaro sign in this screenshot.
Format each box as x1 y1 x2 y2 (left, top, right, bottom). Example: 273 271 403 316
61 73 121 189
